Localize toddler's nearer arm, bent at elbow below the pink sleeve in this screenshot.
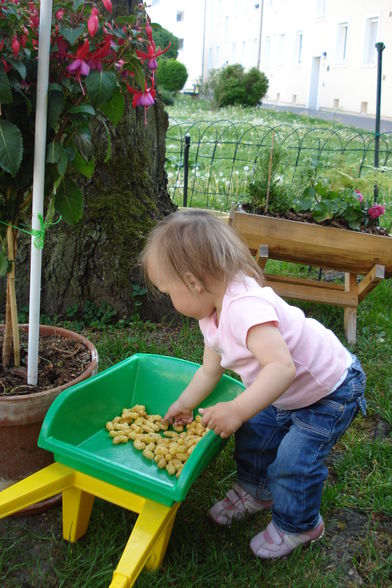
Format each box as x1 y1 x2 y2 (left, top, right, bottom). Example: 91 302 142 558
200 323 295 438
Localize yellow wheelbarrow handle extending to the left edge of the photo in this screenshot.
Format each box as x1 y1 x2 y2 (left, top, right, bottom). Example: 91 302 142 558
0 463 74 518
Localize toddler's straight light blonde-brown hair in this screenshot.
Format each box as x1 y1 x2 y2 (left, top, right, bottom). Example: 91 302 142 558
140 210 263 289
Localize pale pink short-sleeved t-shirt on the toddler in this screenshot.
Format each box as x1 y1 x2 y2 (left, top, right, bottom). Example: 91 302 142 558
199 275 348 410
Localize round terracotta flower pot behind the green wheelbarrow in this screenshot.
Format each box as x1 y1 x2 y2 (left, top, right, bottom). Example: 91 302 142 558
0 325 98 500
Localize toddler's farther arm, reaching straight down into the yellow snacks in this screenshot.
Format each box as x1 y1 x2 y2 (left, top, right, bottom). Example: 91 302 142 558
163 347 223 424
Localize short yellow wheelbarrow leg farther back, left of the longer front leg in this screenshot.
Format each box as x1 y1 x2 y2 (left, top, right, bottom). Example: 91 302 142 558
63 487 95 543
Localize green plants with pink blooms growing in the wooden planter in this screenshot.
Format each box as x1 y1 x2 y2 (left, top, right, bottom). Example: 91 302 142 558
243 155 390 235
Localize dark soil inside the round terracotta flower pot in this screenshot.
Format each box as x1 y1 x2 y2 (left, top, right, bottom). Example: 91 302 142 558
0 332 90 396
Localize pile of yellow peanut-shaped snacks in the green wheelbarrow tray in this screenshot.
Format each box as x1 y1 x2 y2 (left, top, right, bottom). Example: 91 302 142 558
106 404 207 478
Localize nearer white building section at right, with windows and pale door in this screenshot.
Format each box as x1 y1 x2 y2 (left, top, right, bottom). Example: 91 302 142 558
261 0 392 117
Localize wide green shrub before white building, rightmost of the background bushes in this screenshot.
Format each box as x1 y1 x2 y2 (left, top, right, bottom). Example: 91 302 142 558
214 63 268 106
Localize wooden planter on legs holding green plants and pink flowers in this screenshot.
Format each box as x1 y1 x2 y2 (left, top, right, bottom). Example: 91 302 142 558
230 156 392 343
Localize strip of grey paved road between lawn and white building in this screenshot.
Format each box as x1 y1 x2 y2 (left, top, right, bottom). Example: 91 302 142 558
261 102 392 133
